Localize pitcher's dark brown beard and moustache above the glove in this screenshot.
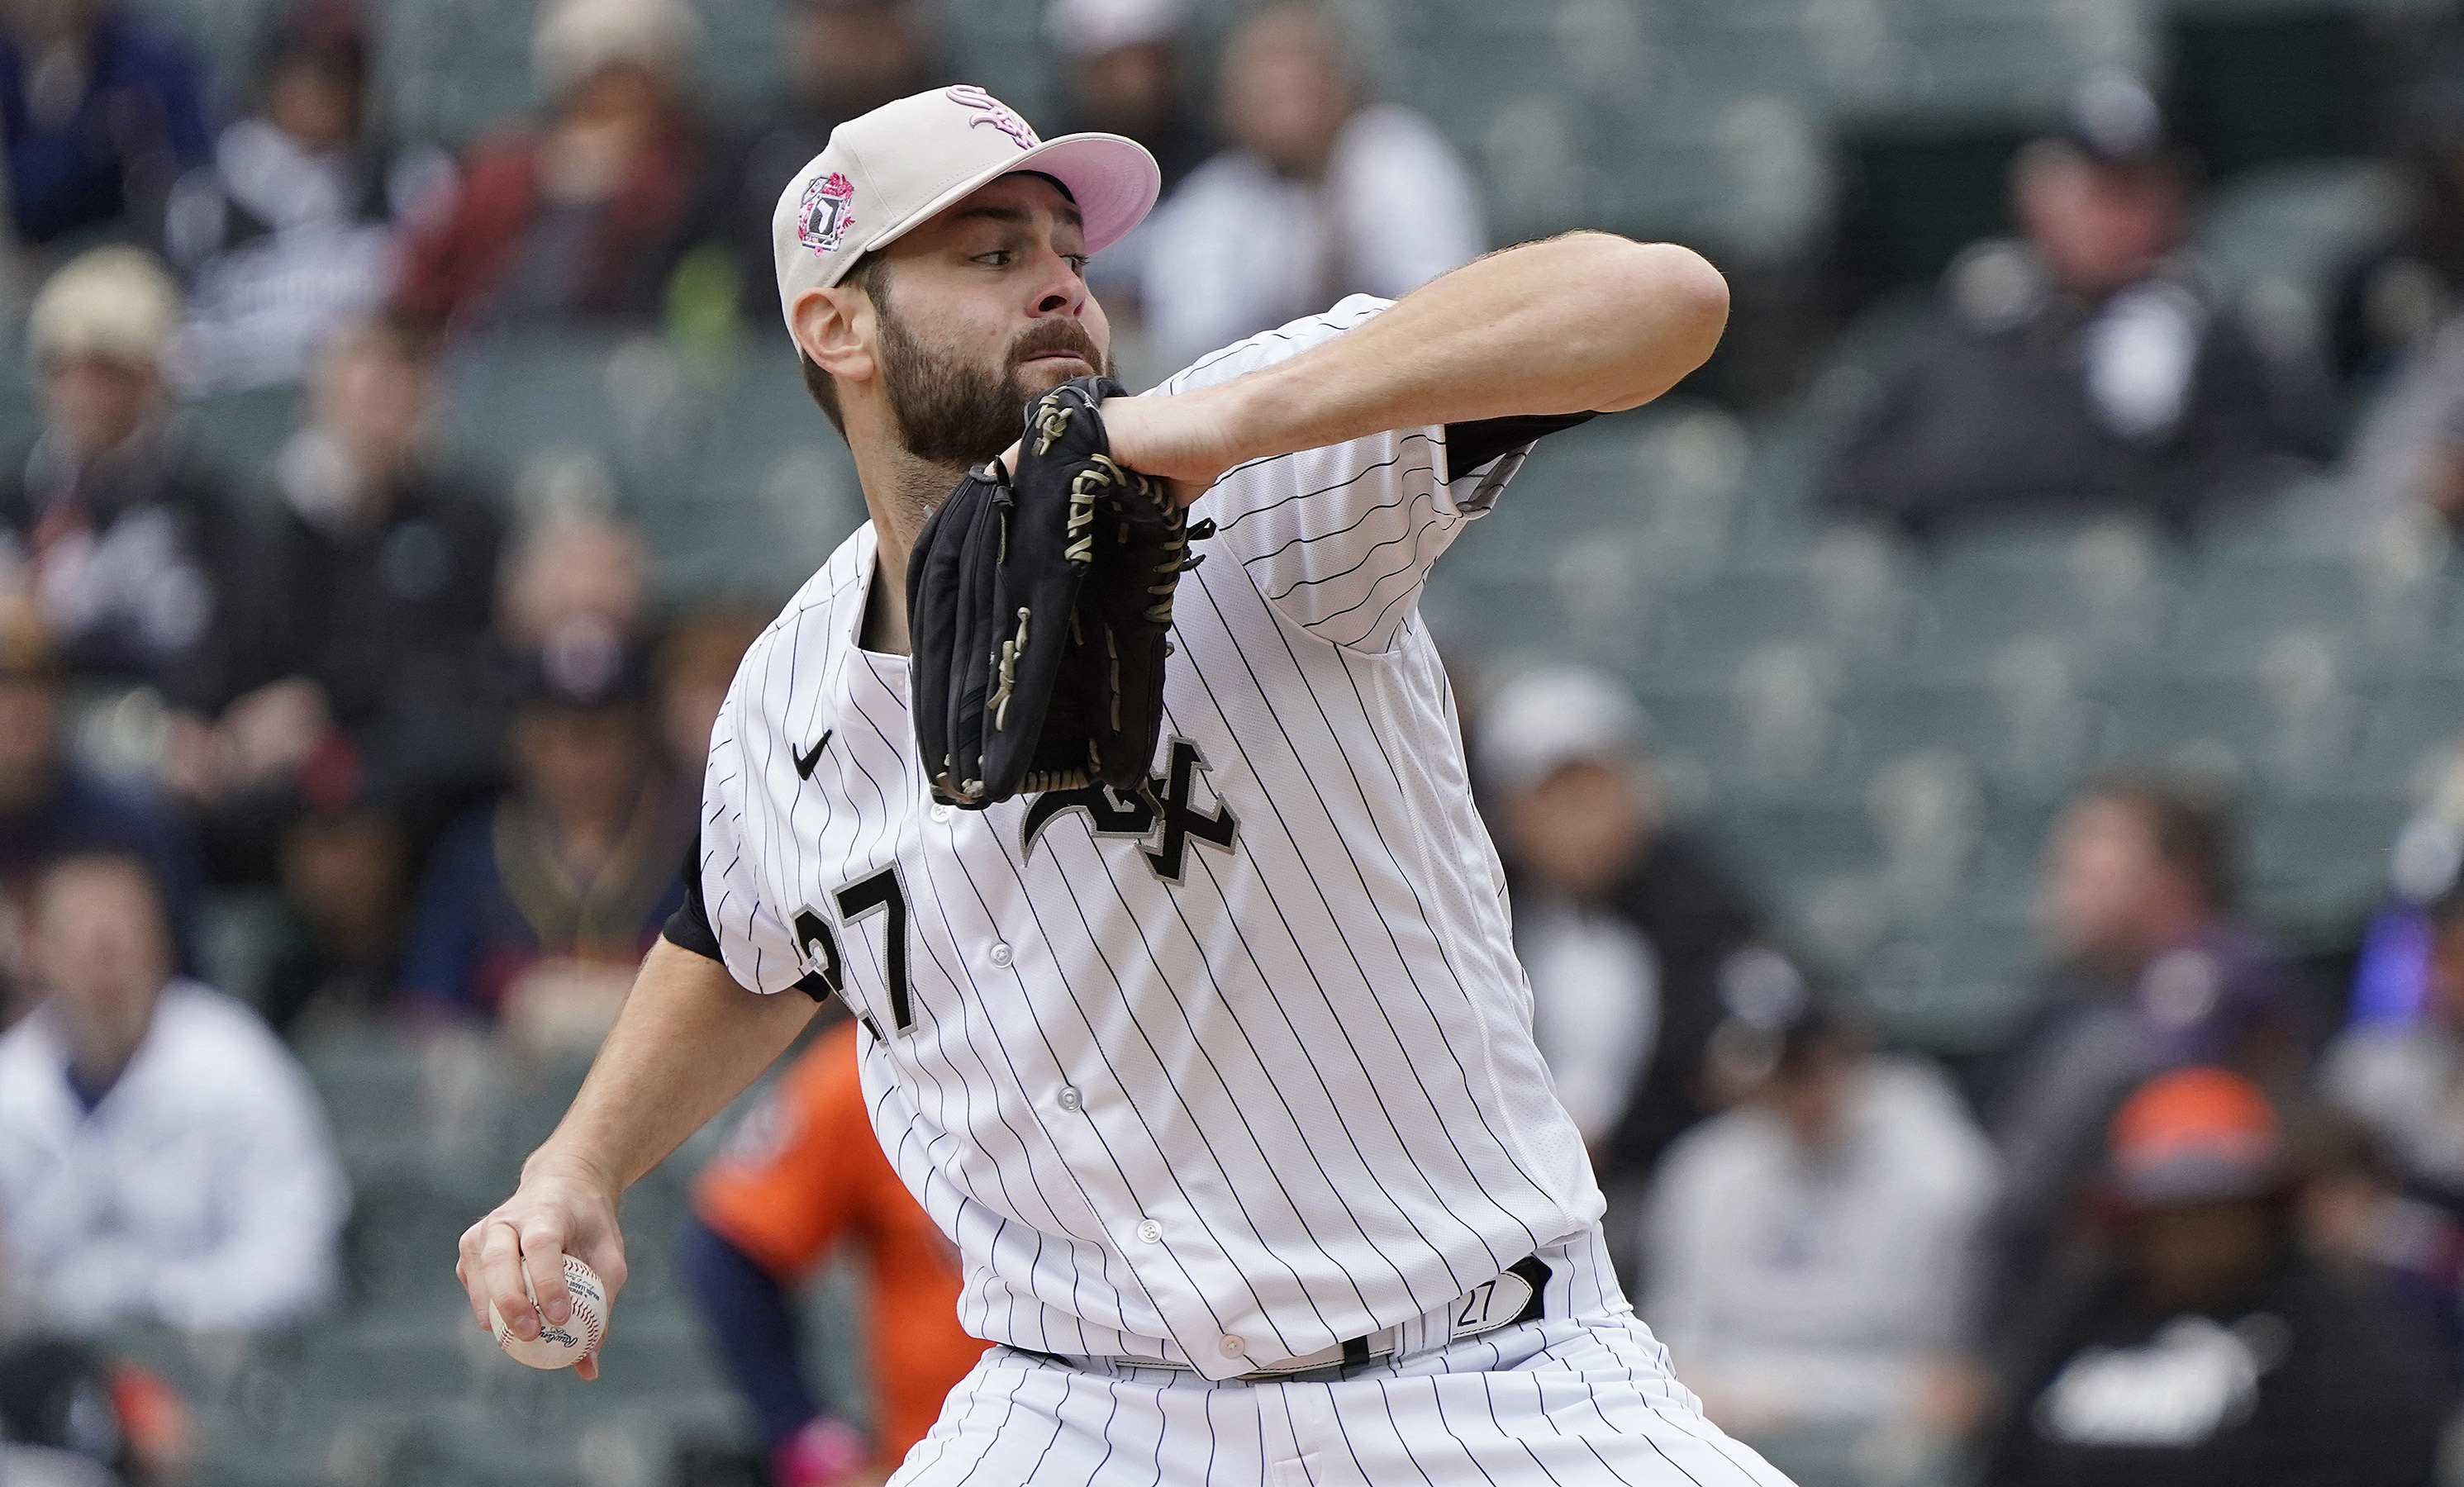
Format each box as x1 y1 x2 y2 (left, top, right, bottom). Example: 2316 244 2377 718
875 296 1111 470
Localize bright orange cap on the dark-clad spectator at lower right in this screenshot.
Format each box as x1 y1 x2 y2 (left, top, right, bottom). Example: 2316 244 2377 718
2107 1068 2284 1209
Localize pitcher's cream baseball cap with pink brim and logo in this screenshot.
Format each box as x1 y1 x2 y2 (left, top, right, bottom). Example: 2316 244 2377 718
771 83 1163 335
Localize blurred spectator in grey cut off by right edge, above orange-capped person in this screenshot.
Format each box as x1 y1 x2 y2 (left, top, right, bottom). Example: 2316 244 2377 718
2321 886 2464 1214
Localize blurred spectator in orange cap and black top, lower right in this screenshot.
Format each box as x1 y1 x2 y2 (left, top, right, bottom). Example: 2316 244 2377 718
1986 1068 2444 1487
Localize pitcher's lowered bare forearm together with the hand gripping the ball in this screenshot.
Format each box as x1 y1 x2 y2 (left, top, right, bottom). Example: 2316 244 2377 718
454 940 816 1379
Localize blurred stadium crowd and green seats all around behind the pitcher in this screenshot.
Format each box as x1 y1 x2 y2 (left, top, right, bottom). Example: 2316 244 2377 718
0 0 2464 1487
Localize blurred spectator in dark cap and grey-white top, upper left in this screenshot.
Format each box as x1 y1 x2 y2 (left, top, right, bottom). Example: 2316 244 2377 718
165 0 454 394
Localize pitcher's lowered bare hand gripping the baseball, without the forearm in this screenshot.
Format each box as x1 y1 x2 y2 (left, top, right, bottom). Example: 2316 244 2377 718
454 1160 626 1379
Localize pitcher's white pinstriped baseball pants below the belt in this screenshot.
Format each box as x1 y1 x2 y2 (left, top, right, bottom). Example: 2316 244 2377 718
892 1231 1784 1487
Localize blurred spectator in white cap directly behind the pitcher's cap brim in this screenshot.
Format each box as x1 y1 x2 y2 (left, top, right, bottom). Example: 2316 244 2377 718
1044 0 1212 327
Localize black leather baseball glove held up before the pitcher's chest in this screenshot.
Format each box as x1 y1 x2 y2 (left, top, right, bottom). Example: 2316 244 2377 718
906 377 1215 810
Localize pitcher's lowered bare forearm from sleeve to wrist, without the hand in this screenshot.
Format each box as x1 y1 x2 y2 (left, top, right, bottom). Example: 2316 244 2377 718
522 940 818 1196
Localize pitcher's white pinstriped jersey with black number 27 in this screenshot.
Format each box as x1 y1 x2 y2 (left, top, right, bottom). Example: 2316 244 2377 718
700 296 1601 1379
